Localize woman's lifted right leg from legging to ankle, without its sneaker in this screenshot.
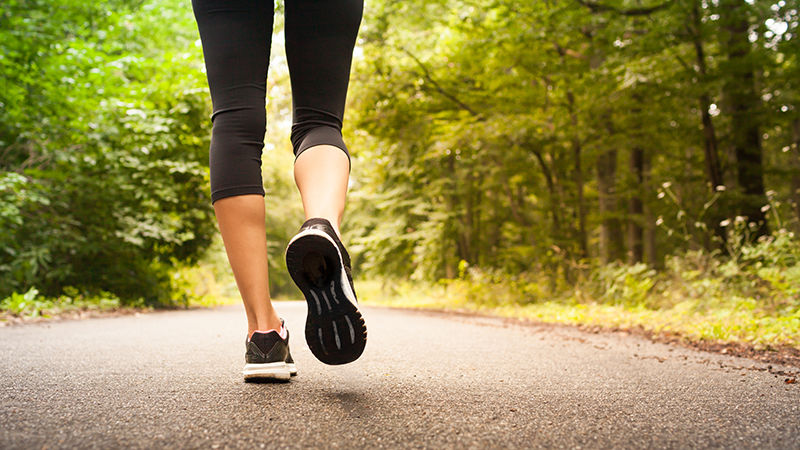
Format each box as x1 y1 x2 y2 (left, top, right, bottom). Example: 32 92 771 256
285 0 364 229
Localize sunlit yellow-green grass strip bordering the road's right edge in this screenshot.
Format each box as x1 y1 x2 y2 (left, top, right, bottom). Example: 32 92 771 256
358 280 800 349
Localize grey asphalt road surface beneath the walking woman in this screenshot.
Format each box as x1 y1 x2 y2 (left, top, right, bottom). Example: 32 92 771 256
0 302 800 449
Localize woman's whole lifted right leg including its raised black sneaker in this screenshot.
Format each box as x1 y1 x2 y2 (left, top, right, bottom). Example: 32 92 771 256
285 0 367 364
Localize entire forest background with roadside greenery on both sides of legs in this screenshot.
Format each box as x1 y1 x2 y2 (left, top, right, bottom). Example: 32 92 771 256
0 0 800 348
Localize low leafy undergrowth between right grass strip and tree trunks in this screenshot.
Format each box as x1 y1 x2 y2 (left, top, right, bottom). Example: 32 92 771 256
400 230 800 317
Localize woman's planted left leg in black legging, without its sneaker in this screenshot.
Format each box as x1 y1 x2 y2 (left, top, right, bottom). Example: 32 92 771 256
192 0 281 335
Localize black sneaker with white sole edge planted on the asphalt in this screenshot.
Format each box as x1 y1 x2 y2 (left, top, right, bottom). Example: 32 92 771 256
242 330 297 381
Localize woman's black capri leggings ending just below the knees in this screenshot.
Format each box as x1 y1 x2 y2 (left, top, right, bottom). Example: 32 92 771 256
192 0 364 203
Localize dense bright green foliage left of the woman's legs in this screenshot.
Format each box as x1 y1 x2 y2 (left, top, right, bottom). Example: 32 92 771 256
0 0 215 304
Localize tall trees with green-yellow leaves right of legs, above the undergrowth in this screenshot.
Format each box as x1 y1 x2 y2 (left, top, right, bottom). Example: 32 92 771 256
348 0 800 284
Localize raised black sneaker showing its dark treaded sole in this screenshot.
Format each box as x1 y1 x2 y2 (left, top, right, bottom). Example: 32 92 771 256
286 218 367 364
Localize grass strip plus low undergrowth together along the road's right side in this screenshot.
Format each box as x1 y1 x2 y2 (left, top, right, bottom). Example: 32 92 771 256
359 231 800 348
